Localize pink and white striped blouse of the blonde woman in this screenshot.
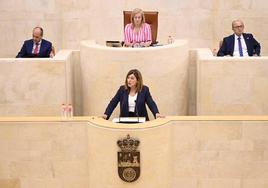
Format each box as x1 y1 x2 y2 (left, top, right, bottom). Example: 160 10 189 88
125 23 152 43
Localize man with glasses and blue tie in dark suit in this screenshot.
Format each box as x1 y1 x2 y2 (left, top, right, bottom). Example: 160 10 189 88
217 20 261 57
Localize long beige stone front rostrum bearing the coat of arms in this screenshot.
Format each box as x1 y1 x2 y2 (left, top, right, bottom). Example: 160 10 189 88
0 116 268 188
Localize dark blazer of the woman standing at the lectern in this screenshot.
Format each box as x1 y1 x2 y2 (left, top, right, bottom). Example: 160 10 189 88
104 86 159 121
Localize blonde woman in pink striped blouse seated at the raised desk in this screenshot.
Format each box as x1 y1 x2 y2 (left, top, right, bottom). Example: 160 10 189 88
124 9 152 47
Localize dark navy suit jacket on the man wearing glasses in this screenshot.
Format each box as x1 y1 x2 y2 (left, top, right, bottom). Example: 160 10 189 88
217 33 261 56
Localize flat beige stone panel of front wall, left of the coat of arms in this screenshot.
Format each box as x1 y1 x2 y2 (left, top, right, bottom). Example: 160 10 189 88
0 121 88 188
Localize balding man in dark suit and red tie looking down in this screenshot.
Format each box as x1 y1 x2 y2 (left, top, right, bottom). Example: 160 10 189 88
16 27 52 58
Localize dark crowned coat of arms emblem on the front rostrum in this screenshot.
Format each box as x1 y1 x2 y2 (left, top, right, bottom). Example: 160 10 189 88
117 135 140 182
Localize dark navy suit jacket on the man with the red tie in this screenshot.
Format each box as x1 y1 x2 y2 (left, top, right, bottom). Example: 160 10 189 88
16 39 52 58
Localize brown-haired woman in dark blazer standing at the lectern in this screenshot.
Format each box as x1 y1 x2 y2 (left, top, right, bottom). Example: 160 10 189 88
102 69 164 121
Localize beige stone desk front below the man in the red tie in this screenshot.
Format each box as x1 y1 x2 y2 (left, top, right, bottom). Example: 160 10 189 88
0 50 74 116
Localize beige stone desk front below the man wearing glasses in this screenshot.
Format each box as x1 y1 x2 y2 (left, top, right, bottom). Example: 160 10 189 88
196 49 268 115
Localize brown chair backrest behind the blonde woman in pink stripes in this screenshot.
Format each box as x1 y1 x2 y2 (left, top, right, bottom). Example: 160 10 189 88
123 11 158 44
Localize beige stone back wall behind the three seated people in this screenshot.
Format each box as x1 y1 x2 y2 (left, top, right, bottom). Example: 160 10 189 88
0 0 268 57
